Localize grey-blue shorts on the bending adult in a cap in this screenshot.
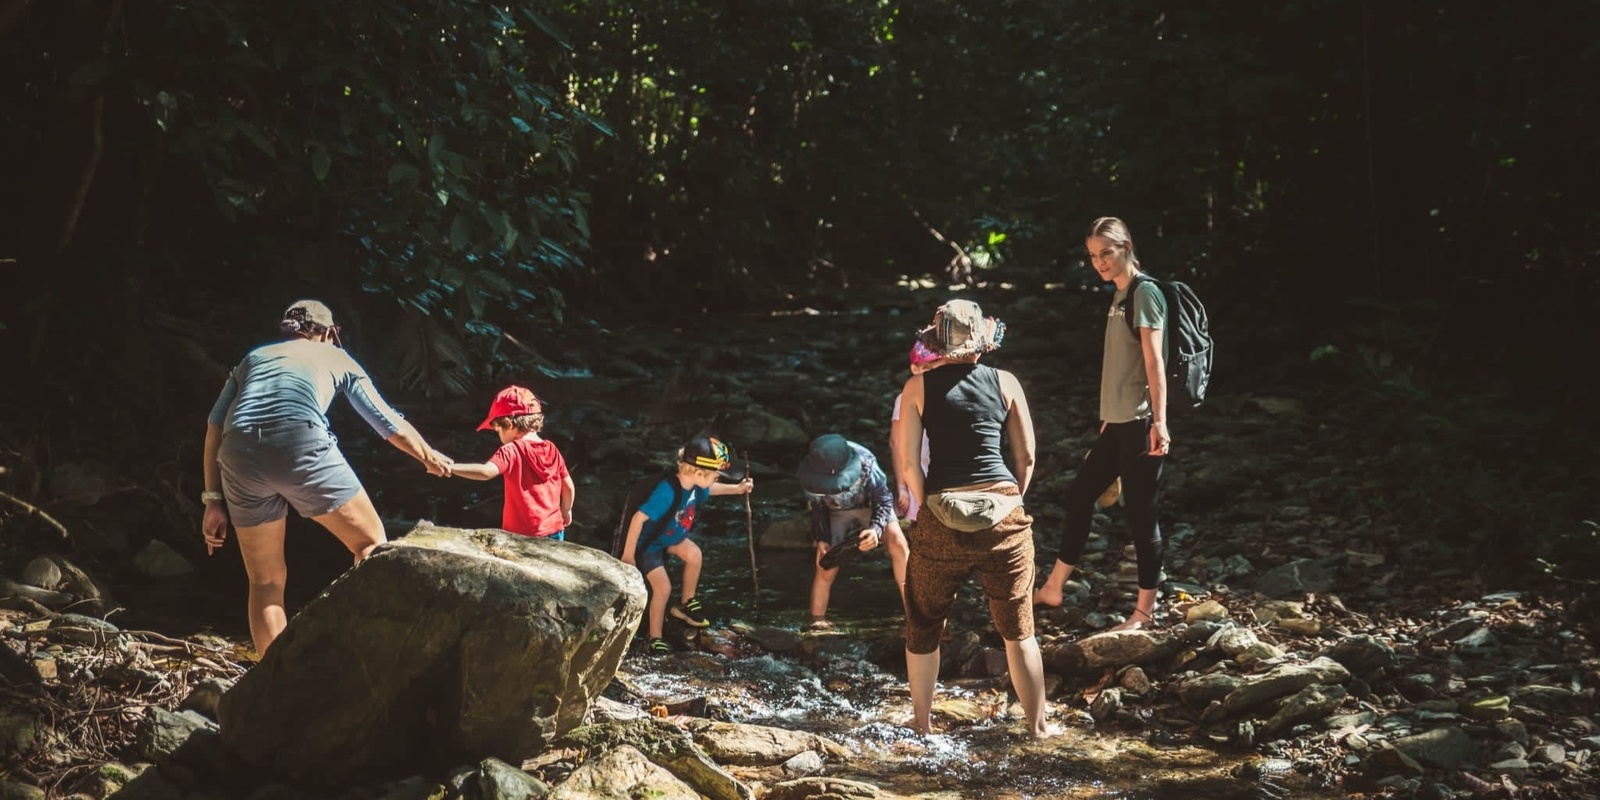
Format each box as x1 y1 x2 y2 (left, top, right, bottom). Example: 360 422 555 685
218 421 362 528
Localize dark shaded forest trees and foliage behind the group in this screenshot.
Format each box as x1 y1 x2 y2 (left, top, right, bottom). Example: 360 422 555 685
0 0 1600 581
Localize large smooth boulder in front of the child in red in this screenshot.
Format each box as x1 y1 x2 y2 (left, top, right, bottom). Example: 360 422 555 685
218 522 645 784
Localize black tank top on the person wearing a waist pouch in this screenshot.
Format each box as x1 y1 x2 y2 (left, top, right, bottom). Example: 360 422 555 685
922 363 1016 493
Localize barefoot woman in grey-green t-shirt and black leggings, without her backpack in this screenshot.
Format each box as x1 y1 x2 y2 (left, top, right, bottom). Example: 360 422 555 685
1034 216 1173 630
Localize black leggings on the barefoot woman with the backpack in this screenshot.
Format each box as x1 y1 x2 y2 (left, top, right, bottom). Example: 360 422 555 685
1056 419 1166 589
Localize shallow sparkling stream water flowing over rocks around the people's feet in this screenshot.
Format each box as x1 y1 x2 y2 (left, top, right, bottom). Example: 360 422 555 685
601 498 1342 800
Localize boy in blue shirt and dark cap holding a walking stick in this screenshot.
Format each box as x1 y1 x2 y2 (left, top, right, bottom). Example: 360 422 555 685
622 437 755 654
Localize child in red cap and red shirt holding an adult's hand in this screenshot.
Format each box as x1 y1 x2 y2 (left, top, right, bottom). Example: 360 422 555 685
450 386 573 541
